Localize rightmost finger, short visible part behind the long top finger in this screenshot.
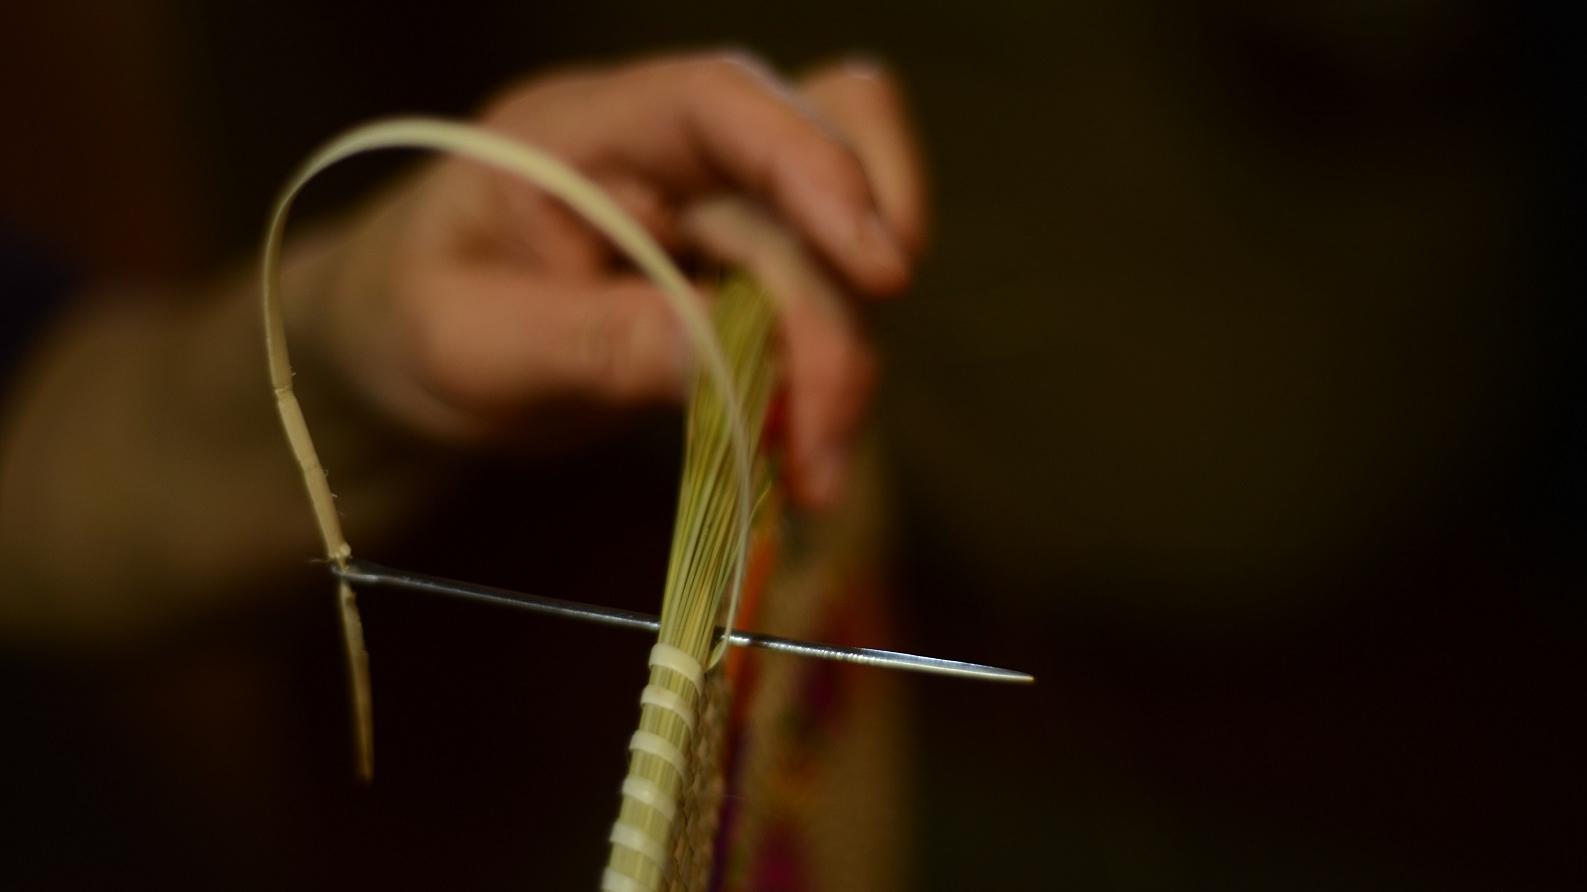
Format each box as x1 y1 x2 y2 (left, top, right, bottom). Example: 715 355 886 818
800 60 927 254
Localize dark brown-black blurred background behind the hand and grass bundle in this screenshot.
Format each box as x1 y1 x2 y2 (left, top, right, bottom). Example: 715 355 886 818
0 0 1587 890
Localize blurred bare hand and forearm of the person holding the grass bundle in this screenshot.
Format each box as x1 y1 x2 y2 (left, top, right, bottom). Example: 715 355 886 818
0 54 927 641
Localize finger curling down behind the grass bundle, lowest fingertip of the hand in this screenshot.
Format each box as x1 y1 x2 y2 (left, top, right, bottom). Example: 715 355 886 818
681 198 874 506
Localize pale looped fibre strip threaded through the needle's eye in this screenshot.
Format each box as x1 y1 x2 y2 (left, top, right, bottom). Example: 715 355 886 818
260 117 751 779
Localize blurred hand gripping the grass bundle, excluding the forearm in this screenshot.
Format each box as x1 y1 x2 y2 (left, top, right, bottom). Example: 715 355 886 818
287 54 925 505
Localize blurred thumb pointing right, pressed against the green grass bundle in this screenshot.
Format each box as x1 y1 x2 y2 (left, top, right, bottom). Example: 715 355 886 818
398 265 689 425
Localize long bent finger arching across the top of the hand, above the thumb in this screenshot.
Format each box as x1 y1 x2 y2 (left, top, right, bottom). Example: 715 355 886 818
489 54 909 294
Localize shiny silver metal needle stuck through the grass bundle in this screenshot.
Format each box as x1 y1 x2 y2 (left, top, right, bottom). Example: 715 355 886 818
332 560 1036 684
